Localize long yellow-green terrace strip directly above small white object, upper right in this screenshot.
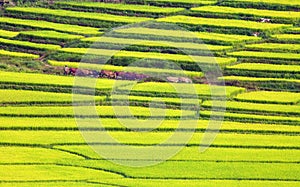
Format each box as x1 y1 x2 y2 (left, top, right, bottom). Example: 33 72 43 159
191 6 300 19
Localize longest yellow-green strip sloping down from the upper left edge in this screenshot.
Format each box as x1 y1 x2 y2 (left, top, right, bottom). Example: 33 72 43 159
0 17 101 35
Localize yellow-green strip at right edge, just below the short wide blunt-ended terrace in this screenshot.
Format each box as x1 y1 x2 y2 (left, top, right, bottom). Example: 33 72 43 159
201 101 300 115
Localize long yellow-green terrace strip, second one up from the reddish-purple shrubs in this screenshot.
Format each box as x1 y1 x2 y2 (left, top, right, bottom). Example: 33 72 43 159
60 48 236 66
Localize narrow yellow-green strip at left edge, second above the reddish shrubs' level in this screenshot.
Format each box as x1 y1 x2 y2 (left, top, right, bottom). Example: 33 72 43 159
0 38 61 50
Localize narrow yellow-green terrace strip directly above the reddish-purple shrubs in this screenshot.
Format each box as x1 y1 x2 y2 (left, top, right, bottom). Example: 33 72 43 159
48 60 203 77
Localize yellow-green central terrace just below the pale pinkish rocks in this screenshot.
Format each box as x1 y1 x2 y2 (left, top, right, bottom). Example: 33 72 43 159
116 82 245 97
